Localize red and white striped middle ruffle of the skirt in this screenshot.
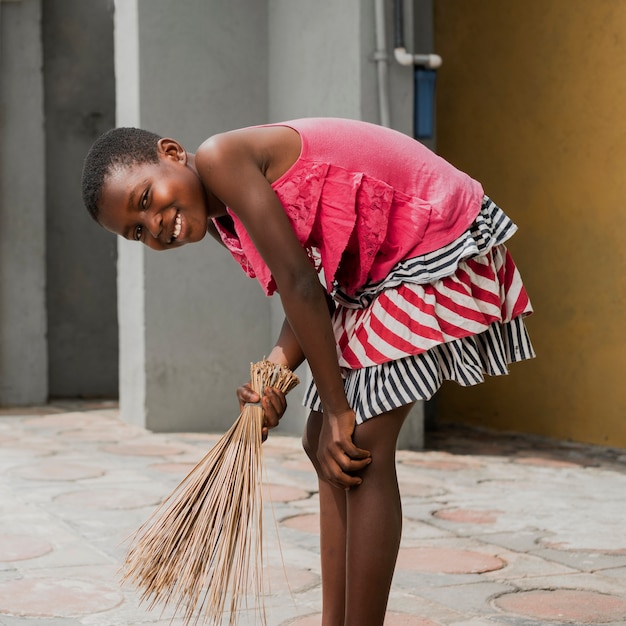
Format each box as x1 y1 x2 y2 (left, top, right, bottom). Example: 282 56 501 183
333 244 532 369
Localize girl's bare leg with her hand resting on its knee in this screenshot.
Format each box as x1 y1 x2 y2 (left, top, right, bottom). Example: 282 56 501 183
344 405 412 626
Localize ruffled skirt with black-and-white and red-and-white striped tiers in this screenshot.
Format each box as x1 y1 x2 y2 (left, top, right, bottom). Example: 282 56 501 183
303 197 535 423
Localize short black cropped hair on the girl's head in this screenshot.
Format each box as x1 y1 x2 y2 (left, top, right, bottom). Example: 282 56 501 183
82 127 161 222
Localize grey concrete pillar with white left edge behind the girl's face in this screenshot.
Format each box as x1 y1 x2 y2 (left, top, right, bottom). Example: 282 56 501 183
115 0 272 431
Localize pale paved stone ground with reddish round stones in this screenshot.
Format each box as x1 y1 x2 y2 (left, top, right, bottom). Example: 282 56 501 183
0 403 626 626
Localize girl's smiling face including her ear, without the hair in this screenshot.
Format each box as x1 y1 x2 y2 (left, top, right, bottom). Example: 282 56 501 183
98 140 209 250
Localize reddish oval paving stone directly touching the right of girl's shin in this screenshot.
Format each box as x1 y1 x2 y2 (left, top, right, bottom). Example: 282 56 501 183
397 547 506 574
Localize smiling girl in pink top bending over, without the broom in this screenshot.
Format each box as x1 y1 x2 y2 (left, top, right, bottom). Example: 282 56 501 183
83 119 534 626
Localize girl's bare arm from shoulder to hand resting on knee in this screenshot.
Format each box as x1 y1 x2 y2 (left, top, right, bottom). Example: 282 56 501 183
196 131 370 489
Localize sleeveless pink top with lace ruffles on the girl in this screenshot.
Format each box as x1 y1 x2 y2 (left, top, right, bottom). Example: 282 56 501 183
214 118 484 296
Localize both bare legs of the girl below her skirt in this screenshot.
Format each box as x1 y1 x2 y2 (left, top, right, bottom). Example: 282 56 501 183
303 405 412 626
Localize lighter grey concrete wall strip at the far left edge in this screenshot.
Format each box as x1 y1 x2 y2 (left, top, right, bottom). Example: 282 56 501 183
0 0 48 405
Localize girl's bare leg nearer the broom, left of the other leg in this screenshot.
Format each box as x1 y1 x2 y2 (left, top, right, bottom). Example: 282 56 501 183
303 412 346 626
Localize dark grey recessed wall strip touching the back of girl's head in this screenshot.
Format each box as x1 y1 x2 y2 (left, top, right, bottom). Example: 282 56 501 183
42 0 118 397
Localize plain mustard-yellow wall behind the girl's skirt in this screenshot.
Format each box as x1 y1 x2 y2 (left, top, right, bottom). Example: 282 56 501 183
434 0 626 447
